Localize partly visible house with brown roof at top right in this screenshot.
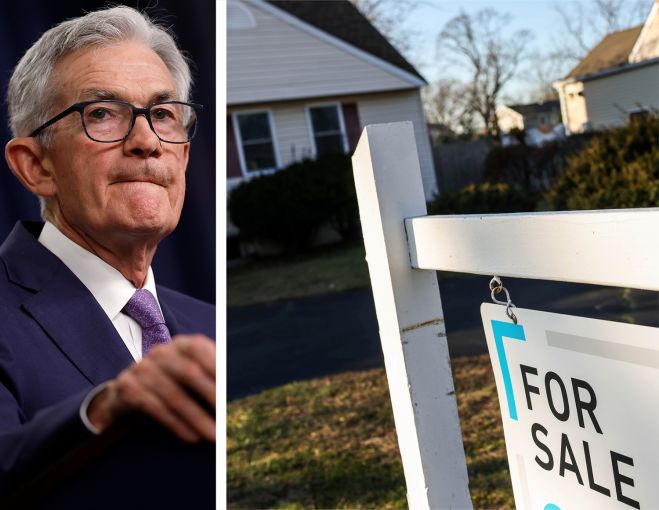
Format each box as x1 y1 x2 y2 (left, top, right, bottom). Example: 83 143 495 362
553 0 659 134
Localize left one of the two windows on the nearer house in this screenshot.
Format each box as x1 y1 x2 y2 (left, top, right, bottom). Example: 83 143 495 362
236 112 277 173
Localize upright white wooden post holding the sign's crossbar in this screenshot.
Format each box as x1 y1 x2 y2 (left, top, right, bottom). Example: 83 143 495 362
353 122 472 509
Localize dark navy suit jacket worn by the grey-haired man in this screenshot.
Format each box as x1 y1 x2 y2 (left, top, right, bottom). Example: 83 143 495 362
0 222 215 493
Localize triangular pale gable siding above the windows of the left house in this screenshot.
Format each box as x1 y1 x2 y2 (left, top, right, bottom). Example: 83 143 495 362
227 2 414 105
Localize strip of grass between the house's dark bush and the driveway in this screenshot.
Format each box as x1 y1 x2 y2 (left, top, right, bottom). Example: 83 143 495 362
227 242 370 306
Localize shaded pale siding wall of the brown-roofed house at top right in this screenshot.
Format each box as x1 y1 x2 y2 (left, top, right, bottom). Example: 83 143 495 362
584 62 659 129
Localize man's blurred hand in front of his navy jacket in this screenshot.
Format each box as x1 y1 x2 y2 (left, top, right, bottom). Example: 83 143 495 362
87 335 215 443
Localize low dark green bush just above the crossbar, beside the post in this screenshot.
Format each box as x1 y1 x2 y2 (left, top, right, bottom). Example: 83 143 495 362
428 182 539 214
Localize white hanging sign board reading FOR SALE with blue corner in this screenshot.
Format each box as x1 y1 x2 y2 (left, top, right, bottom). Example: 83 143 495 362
481 303 659 510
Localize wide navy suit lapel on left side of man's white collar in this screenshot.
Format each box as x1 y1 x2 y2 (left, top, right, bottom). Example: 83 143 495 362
0 221 134 384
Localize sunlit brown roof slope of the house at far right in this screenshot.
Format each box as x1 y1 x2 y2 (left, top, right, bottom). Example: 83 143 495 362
566 25 643 78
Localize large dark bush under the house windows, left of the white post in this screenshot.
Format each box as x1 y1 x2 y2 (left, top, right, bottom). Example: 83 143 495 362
228 155 359 252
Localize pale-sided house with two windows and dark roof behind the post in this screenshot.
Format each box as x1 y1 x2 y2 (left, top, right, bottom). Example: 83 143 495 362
227 0 437 235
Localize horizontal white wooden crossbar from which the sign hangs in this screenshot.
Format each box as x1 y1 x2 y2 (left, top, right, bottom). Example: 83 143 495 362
405 208 659 291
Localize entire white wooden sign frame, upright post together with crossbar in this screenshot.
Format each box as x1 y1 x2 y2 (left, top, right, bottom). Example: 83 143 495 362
353 122 659 509
